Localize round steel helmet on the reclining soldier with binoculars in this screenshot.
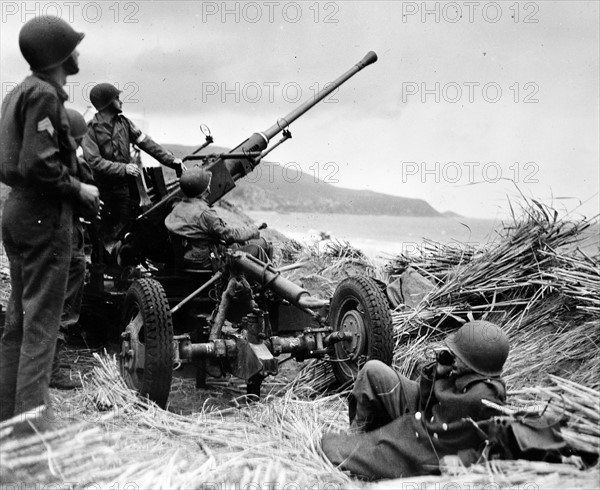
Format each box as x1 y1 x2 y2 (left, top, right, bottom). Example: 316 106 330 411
446 320 509 376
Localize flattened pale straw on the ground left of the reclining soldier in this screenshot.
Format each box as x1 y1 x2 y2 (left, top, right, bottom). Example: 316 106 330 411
0 355 353 488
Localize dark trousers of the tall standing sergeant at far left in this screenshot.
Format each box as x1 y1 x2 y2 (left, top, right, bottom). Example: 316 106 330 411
0 187 73 421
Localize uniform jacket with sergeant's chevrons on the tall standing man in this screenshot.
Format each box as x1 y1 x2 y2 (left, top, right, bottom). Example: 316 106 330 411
0 73 81 203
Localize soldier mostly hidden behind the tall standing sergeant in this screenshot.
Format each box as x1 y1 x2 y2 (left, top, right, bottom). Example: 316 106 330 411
50 108 95 390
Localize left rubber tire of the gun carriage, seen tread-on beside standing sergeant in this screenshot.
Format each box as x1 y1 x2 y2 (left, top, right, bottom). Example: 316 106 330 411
120 279 173 408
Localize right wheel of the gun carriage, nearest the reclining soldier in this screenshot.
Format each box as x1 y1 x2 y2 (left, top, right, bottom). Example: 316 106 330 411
329 276 394 384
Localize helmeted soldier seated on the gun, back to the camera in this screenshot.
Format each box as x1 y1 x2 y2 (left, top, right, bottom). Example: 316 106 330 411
165 167 269 269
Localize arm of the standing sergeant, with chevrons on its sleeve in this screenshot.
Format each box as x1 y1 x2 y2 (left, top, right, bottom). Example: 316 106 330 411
19 90 81 200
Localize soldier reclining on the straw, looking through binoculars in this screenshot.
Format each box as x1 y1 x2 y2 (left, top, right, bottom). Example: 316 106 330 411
322 321 509 479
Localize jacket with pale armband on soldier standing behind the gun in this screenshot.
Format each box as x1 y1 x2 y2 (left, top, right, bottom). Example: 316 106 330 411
81 114 174 187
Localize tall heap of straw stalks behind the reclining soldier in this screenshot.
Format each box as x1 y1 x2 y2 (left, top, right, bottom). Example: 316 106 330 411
292 201 600 392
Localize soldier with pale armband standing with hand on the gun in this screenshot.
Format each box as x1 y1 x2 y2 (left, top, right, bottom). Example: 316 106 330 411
81 83 183 252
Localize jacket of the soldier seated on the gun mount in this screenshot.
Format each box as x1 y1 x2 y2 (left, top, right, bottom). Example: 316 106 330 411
165 197 259 267
